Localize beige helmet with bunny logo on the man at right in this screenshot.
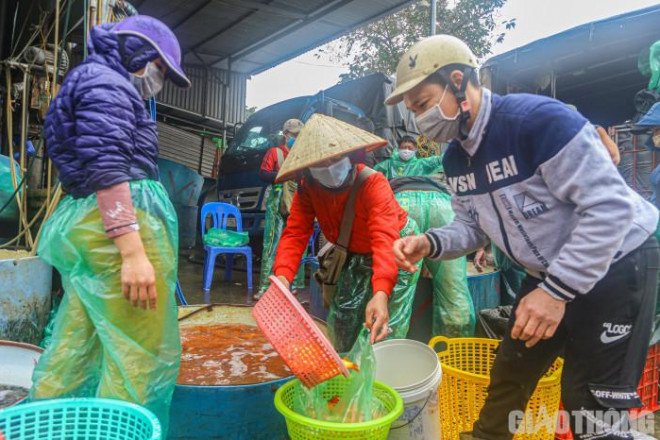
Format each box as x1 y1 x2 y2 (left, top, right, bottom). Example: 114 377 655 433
385 35 477 105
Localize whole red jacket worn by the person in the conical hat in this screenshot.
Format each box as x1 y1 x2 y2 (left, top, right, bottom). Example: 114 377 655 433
274 165 408 295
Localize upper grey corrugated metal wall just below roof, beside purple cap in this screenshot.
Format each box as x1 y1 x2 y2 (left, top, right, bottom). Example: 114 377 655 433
158 62 248 124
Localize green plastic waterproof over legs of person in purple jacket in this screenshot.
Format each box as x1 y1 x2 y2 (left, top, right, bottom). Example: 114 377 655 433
30 180 181 433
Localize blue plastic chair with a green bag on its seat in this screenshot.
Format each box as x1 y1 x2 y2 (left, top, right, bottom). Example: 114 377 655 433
201 202 252 295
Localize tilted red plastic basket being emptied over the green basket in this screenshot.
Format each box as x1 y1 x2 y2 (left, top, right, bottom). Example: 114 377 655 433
252 276 349 388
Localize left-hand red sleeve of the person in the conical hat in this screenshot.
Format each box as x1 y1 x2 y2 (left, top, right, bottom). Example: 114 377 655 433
273 189 316 282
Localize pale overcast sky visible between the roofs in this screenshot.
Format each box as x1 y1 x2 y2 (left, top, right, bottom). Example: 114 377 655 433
247 0 658 108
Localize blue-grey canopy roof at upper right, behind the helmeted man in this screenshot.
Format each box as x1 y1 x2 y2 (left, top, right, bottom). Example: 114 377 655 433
481 5 660 126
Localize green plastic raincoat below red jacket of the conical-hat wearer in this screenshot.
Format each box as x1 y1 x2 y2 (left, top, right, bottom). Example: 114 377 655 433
328 218 421 353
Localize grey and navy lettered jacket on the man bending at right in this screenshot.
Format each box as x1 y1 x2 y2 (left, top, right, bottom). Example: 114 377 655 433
426 89 658 301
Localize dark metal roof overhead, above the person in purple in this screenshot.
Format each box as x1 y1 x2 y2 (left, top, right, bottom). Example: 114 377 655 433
137 0 413 75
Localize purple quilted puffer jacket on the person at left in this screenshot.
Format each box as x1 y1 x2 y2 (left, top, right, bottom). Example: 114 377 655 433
44 25 158 198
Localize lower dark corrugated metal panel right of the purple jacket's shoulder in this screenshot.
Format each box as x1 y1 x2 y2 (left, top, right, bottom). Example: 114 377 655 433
158 121 217 177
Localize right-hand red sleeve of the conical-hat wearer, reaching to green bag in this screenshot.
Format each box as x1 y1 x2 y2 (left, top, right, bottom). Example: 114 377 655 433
358 173 401 296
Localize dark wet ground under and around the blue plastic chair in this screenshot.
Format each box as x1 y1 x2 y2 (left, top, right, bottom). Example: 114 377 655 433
174 247 309 305
